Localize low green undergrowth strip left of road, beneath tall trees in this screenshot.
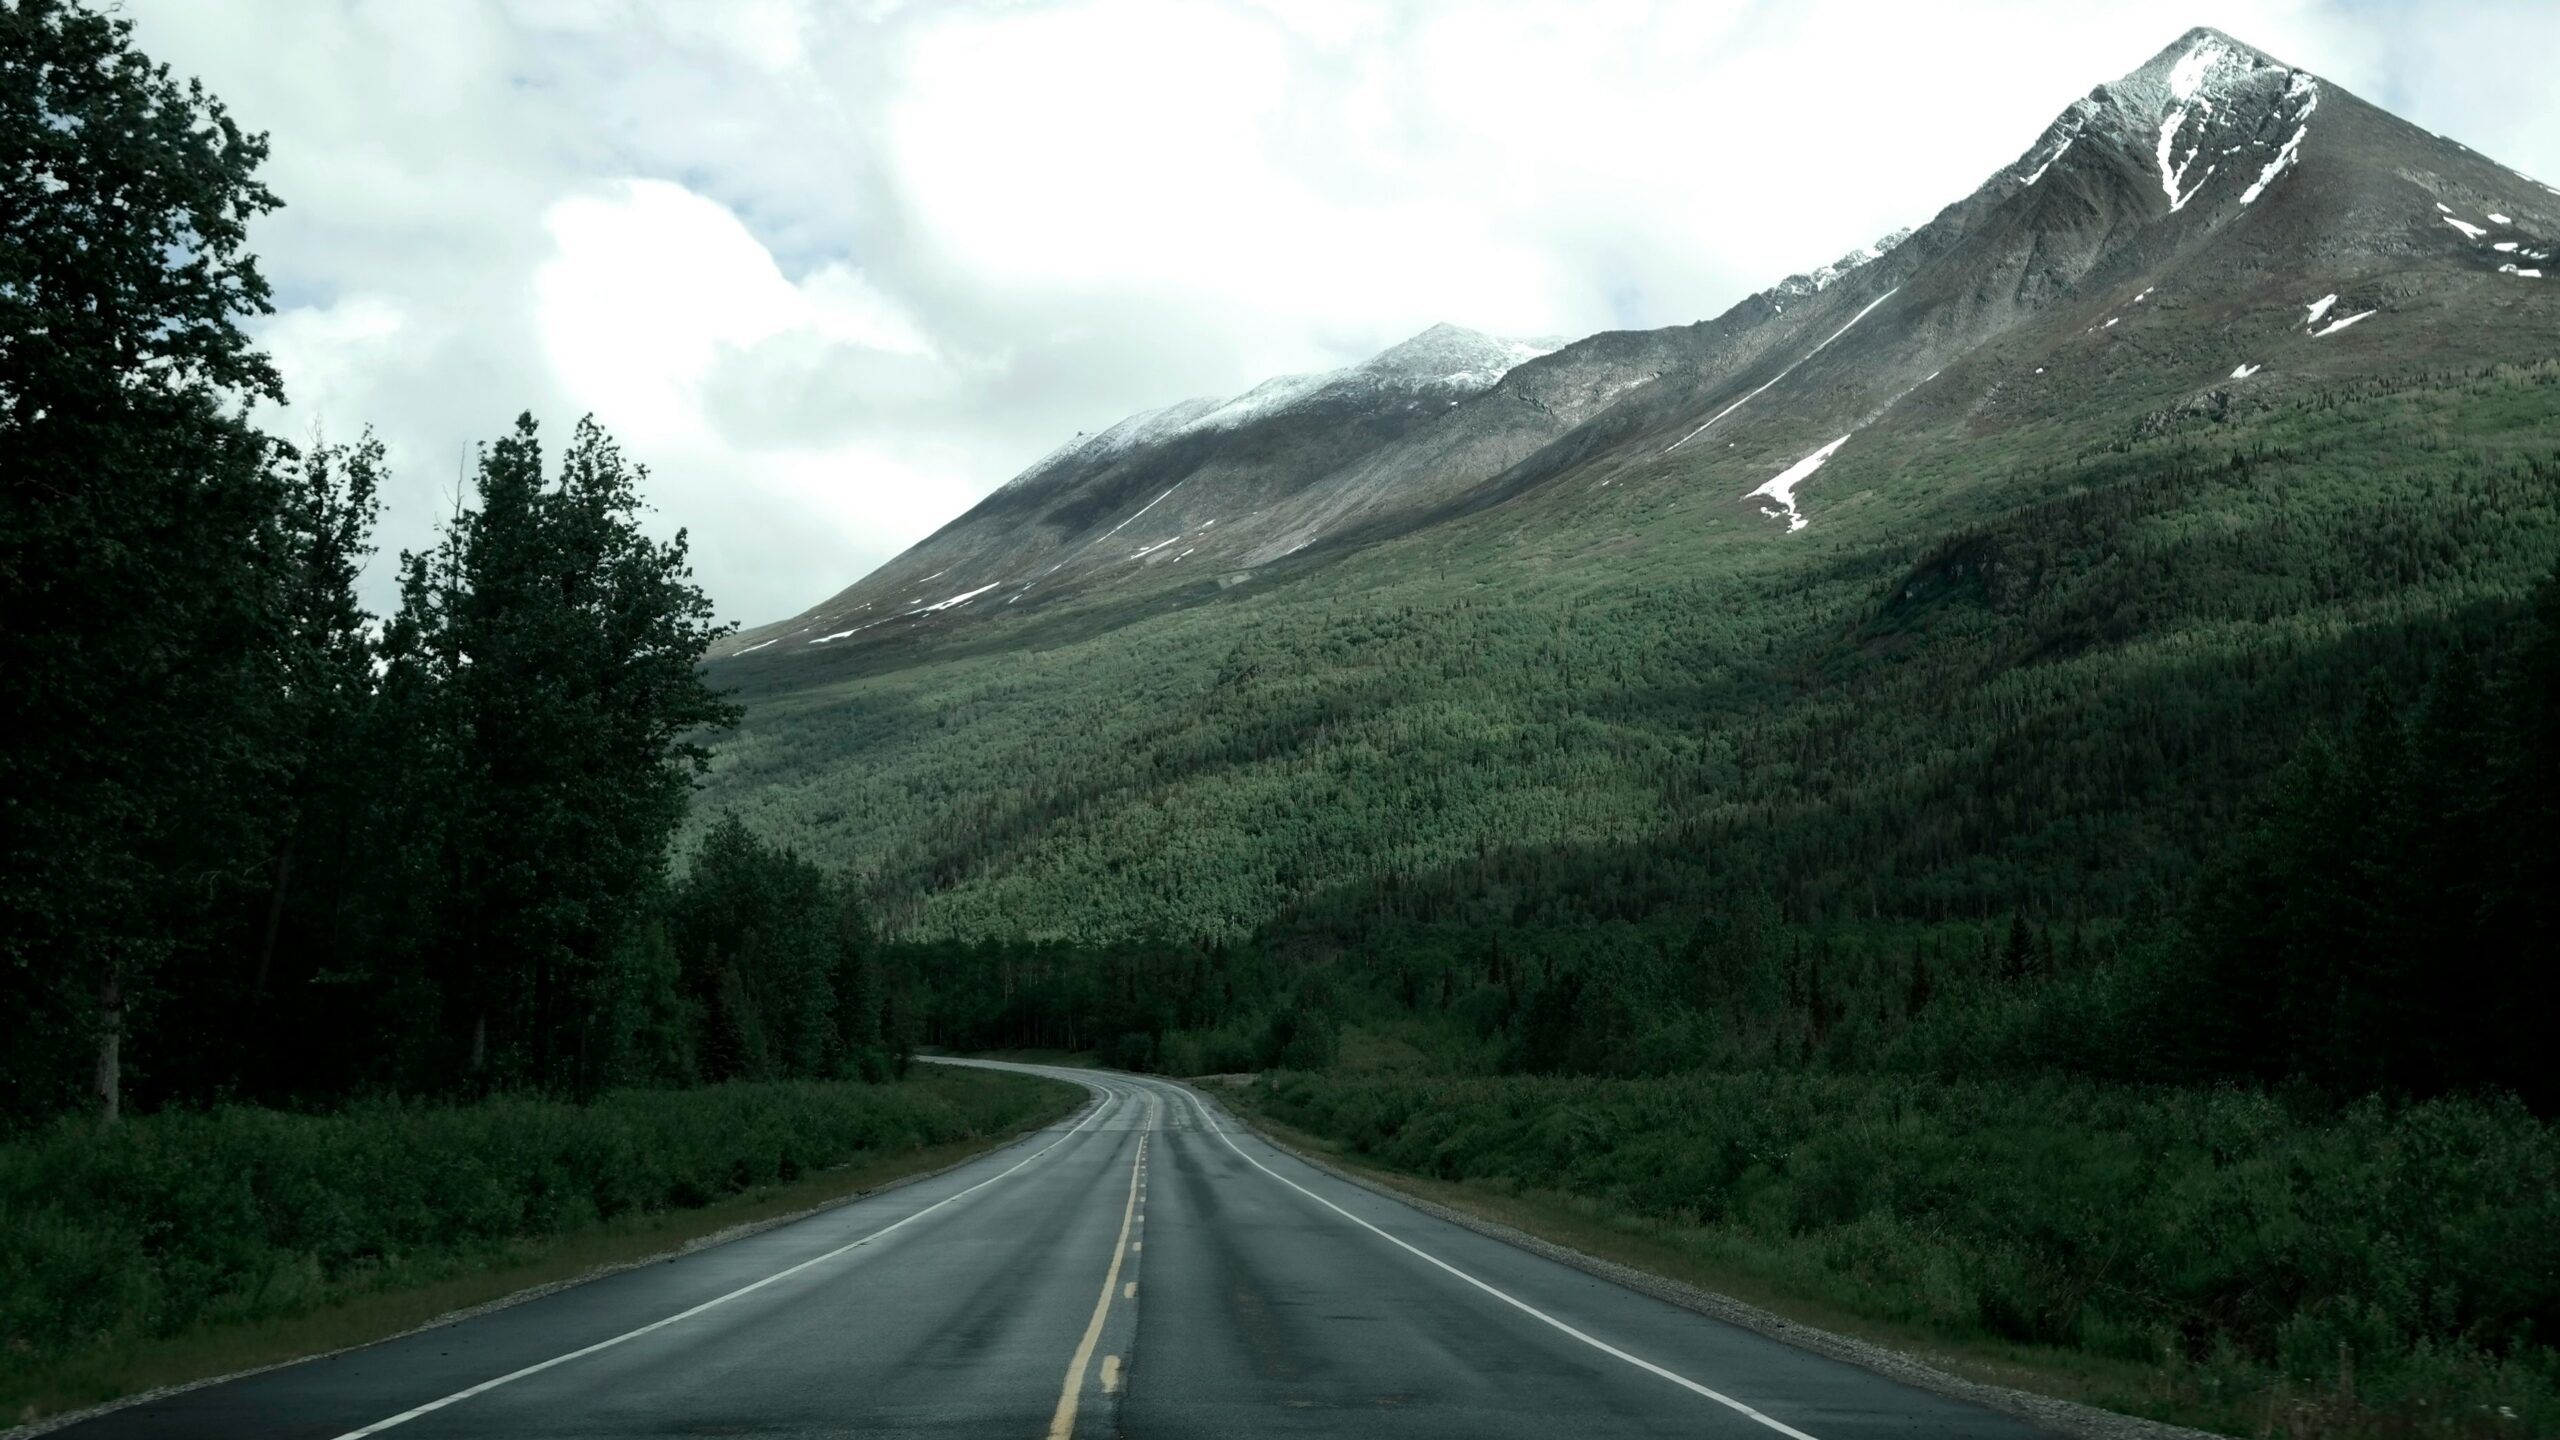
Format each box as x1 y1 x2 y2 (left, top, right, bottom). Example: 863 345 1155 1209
0 1068 1078 1404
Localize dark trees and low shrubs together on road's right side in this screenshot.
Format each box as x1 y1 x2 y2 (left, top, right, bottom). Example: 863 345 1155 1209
855 556 2560 1440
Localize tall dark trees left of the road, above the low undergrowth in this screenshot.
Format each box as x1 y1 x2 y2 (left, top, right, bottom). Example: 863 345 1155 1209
0 0 906 1125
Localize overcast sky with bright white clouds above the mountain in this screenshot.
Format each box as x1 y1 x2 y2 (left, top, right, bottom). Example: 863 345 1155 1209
125 0 2560 623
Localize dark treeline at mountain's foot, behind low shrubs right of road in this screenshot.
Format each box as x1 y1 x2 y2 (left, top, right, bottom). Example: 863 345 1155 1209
886 561 2560 1112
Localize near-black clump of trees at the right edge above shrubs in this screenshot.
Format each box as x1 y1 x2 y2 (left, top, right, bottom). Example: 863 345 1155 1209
2153 577 2560 1112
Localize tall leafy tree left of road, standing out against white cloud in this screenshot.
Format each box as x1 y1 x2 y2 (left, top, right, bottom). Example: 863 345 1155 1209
384 415 737 1089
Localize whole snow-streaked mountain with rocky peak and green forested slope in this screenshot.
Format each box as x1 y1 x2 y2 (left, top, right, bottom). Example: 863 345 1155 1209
691 31 2560 935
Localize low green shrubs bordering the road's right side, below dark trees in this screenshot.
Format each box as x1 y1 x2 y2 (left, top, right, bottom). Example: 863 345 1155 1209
1244 1074 2560 1435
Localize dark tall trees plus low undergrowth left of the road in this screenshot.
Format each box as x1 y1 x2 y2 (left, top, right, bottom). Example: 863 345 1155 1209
0 11 1083 1425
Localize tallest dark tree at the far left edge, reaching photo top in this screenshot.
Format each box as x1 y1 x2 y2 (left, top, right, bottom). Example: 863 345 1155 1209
0 0 282 1117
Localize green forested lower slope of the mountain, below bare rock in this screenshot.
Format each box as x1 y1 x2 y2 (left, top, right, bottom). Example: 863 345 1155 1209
696 364 2560 940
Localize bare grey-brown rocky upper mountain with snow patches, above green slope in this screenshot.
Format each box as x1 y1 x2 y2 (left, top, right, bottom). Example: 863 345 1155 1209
722 28 2560 666
